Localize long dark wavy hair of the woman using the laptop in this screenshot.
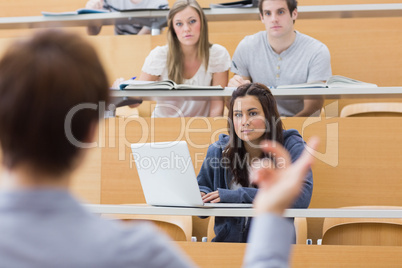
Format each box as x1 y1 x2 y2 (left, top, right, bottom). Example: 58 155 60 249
223 83 283 187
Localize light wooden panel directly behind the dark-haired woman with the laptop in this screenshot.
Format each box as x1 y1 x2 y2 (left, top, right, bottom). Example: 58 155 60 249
90 117 402 239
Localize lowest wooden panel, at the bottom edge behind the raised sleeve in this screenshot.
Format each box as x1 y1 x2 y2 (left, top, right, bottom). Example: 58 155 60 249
177 242 402 268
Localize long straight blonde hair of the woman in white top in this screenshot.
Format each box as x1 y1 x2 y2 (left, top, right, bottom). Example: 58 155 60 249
167 0 211 84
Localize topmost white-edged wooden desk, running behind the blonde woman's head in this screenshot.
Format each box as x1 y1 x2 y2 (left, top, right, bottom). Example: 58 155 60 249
0 4 402 29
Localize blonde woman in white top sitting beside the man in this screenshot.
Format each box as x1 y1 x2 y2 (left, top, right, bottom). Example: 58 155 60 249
139 0 230 117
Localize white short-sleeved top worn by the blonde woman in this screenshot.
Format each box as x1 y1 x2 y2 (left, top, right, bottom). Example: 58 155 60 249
142 44 230 117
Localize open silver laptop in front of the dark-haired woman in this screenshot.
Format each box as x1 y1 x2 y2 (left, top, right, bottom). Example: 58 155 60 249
131 141 252 208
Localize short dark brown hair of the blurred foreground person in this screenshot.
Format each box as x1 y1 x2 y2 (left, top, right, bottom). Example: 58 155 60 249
0 30 109 175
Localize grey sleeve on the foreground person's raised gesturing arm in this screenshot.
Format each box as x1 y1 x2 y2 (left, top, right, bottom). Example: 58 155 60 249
243 214 294 268
